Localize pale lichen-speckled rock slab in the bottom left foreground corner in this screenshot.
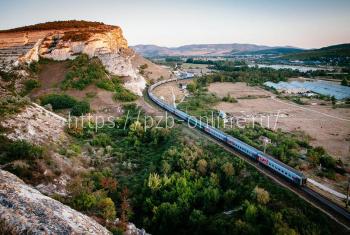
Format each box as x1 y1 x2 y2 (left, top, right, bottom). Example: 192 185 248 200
0 170 111 234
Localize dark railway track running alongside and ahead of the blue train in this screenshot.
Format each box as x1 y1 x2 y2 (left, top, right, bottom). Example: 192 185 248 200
146 79 350 231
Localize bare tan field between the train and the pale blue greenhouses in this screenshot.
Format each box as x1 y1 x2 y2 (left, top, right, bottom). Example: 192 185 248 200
209 83 350 163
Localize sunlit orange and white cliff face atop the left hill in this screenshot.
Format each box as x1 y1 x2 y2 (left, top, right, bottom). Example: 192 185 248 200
0 22 146 96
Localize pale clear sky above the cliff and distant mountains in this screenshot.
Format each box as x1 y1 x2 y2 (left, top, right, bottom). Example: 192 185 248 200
0 0 350 48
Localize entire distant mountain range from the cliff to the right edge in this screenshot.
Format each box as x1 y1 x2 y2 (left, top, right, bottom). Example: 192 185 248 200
132 43 350 60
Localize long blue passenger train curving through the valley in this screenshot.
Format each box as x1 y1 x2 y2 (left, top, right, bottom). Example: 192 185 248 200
147 78 307 186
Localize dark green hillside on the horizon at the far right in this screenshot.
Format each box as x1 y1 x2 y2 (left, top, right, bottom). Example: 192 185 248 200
284 43 350 60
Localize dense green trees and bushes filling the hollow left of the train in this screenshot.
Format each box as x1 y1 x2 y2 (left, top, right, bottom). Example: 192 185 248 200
60 105 330 234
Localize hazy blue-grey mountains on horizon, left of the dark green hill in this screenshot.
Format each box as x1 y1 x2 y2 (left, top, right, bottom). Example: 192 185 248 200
132 43 271 57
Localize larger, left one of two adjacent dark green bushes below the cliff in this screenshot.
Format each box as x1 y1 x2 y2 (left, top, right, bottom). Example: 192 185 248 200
41 94 77 110
